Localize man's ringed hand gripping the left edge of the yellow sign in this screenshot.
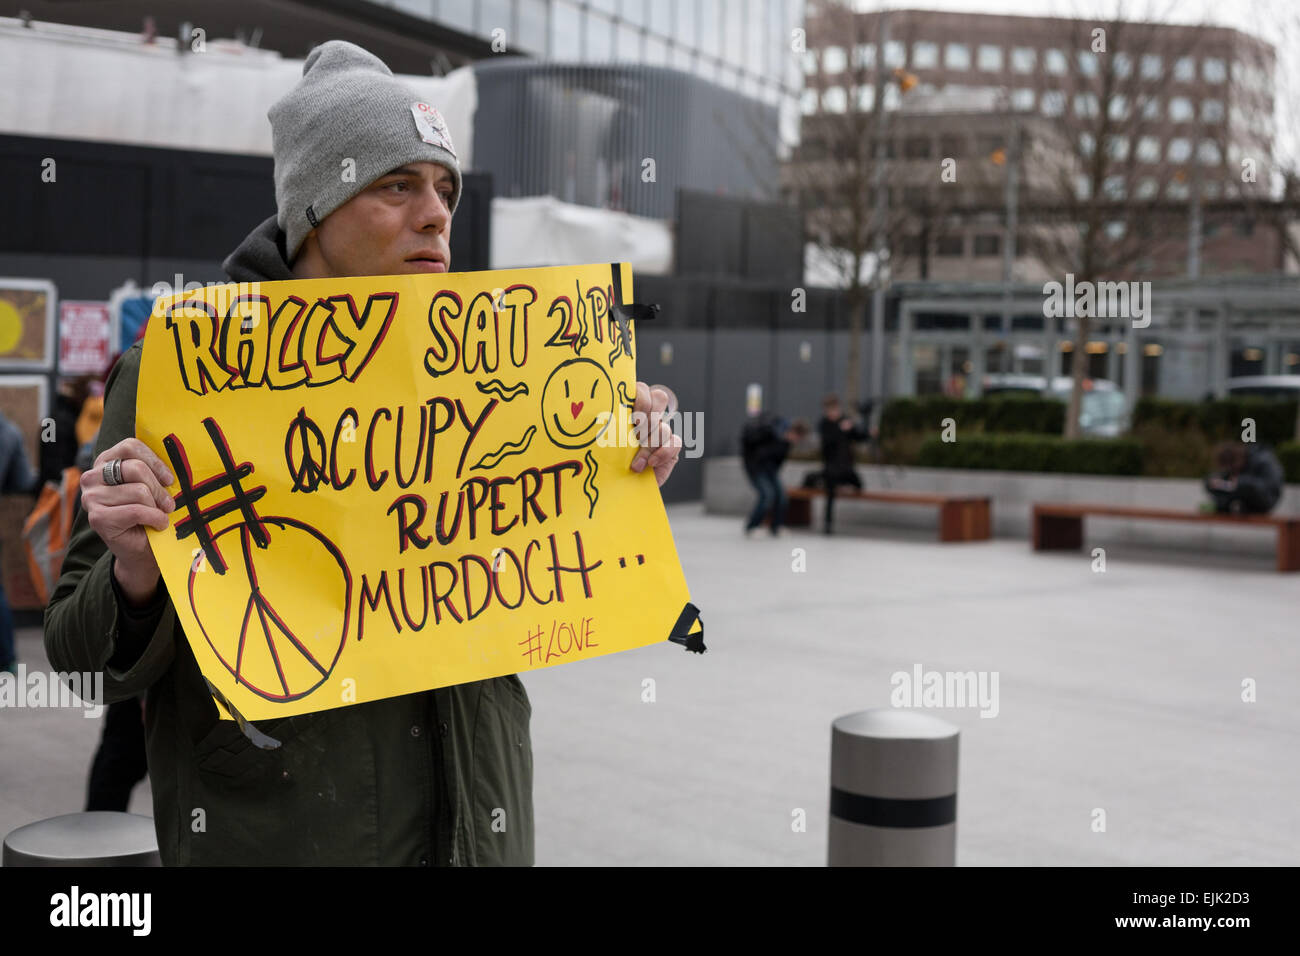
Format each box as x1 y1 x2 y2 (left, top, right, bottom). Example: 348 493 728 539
81 438 176 605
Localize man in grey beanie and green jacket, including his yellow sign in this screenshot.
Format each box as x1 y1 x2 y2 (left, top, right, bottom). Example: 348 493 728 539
46 42 694 865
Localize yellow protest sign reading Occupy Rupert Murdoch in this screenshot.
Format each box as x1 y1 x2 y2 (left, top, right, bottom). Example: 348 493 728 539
137 265 702 719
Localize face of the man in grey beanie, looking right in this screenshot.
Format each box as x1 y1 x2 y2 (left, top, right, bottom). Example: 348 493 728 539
294 163 455 278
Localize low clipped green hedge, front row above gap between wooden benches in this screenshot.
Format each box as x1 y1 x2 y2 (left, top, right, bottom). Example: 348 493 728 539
917 434 1143 475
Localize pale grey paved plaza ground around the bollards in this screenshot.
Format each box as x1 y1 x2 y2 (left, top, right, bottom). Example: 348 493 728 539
0 505 1300 866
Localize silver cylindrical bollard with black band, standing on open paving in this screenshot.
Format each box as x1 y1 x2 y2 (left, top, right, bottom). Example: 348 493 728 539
827 709 959 866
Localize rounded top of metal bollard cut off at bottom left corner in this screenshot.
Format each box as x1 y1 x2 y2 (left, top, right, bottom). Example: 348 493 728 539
3 810 163 866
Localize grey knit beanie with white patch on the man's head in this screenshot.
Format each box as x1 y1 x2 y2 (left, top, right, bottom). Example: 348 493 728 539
267 40 460 263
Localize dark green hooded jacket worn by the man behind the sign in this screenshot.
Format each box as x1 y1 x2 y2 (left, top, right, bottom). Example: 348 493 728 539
44 217 533 866
